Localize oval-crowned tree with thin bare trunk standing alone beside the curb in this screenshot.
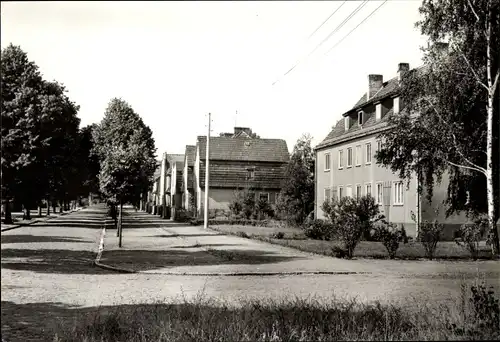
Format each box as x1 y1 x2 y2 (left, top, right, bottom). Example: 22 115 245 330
93 98 157 246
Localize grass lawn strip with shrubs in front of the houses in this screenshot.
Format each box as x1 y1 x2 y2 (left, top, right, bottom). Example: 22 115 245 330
210 225 491 260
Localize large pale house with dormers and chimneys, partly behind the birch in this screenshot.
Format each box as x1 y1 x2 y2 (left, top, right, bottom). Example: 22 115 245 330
315 63 465 239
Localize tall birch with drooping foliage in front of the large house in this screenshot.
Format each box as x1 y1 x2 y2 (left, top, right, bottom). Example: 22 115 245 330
376 0 500 255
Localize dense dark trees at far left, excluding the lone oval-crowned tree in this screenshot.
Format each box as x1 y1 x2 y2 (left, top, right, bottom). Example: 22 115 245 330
1 44 97 223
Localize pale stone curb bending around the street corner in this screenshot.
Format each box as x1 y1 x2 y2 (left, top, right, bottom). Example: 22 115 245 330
94 221 370 277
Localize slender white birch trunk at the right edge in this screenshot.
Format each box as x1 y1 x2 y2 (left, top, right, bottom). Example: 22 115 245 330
486 2 500 256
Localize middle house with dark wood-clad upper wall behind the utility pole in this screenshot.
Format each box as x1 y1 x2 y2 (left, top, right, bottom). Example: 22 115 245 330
193 127 290 216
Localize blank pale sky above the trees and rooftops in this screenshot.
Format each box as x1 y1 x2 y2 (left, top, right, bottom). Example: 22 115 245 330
1 0 426 156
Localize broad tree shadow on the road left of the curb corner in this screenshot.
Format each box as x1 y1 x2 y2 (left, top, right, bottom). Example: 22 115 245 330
2 248 116 275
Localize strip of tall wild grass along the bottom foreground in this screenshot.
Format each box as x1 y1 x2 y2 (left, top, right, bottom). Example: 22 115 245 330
54 286 500 342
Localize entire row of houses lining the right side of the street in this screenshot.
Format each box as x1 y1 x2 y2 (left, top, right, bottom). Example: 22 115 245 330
142 63 476 239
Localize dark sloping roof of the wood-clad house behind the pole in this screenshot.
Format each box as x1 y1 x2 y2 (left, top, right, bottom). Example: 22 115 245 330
198 136 290 163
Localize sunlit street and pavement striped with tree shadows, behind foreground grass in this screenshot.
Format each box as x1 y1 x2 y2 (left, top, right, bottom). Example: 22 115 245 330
1 206 500 341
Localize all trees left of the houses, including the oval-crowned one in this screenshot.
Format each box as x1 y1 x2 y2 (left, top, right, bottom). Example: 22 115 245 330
1 44 157 245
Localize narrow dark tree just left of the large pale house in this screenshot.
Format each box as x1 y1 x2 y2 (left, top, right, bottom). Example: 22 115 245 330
277 134 314 225
